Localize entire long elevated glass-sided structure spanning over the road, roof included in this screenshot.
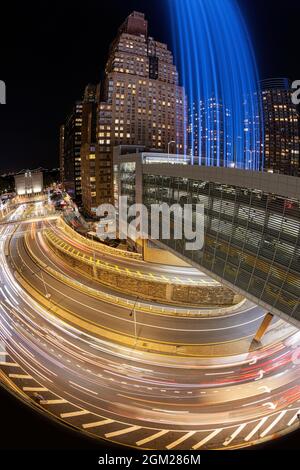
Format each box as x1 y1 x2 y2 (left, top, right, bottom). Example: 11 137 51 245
115 153 300 327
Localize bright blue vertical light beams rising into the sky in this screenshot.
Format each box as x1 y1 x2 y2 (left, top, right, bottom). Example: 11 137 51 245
168 0 263 171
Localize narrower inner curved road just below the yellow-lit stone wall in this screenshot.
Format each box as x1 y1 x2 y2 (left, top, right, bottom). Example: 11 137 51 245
10 221 290 350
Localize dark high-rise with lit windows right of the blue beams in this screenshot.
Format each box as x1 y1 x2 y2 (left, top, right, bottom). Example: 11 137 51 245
261 78 300 176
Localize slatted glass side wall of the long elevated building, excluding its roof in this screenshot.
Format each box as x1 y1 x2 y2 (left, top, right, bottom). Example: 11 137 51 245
142 171 300 321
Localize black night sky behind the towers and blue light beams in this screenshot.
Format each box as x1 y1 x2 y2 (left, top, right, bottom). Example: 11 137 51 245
0 0 300 172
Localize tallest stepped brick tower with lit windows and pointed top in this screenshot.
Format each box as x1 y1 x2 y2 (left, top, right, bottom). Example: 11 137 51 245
83 12 186 213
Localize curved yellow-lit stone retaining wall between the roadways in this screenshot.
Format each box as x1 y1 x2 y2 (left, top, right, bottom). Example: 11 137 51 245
43 230 243 308
